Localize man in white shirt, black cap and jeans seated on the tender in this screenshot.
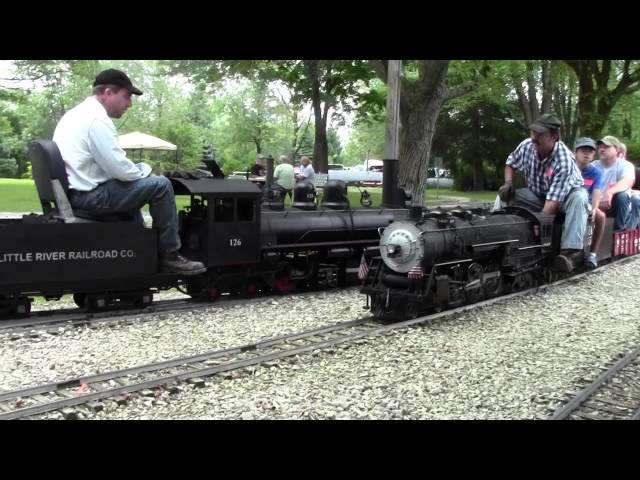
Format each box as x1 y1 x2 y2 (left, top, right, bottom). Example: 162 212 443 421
53 69 206 275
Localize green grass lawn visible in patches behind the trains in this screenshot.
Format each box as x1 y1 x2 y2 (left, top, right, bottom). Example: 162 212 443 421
0 178 496 213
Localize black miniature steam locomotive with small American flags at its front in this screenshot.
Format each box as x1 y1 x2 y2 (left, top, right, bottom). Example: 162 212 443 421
361 201 640 320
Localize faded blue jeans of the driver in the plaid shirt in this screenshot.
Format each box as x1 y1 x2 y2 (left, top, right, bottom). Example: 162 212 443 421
496 188 589 250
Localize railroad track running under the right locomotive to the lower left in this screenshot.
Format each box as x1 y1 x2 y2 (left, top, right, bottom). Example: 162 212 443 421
0 266 632 420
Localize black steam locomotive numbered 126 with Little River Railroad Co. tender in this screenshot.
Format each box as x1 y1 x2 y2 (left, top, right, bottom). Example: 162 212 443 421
0 140 406 318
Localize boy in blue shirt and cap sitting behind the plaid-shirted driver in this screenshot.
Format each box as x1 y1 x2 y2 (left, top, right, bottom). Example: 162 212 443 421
575 137 606 268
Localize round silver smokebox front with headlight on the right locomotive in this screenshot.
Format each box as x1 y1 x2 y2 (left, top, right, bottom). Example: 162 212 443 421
380 222 424 273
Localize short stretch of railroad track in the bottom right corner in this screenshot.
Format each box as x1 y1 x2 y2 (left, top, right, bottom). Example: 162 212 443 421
549 345 640 420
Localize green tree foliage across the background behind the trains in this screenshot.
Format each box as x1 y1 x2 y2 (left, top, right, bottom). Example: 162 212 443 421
0 59 640 197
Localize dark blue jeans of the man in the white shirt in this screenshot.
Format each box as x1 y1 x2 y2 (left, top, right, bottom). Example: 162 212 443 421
69 176 181 254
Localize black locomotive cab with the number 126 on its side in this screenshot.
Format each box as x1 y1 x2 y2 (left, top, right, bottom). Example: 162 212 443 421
171 178 262 267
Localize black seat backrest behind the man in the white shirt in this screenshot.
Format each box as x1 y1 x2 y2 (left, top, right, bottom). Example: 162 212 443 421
27 140 69 213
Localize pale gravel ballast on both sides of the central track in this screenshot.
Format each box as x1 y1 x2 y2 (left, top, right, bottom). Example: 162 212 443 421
0 258 640 419
